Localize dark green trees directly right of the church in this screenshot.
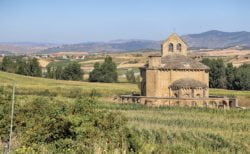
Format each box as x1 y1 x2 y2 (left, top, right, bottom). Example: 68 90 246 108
202 58 250 90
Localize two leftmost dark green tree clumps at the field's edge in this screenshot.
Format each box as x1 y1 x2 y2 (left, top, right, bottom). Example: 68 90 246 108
0 56 83 80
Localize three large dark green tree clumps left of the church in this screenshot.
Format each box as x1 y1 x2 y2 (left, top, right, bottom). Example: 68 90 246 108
0 56 118 82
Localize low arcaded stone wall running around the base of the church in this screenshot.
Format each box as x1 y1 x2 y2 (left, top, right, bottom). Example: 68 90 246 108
120 95 238 109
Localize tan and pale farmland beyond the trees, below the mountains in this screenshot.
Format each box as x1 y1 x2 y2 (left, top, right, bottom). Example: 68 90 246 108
34 49 250 82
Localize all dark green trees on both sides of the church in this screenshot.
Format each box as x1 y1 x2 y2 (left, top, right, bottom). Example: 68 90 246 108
0 56 250 90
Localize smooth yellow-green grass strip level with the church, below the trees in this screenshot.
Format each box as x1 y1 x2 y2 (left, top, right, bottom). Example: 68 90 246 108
0 71 250 97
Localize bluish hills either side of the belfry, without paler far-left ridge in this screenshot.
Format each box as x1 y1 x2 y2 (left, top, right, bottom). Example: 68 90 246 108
41 30 250 53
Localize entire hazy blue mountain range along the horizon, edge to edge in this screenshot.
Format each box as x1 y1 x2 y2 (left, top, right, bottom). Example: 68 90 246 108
0 30 250 53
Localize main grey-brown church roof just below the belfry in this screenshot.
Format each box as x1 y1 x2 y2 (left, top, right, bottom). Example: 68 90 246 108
161 55 209 70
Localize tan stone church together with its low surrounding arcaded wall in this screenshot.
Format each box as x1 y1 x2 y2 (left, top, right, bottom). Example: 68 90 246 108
120 33 237 108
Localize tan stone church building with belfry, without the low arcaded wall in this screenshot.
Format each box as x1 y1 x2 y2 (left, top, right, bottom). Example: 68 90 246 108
141 34 209 98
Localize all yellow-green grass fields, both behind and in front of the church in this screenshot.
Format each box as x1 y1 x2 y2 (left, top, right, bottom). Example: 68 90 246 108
0 72 250 153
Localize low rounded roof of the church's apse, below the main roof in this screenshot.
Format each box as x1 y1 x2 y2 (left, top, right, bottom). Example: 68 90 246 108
169 78 208 89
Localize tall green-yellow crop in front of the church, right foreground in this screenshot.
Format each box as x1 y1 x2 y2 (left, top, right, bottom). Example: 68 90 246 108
96 102 250 153
